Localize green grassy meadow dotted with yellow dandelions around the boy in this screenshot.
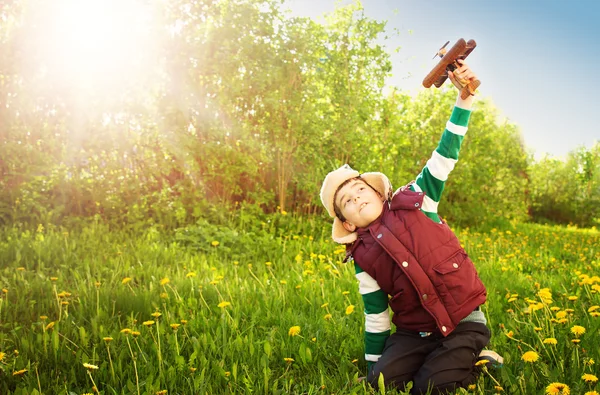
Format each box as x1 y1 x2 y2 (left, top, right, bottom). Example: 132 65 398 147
0 218 600 394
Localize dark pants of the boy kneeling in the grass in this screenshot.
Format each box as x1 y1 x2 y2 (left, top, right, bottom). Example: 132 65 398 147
368 322 491 394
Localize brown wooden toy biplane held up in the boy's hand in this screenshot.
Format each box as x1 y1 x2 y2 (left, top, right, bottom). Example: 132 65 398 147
423 38 481 99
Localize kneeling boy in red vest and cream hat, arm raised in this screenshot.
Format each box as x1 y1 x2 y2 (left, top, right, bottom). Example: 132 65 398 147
320 61 502 394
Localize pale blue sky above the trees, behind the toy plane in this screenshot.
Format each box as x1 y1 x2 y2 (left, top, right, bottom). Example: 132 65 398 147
286 0 600 158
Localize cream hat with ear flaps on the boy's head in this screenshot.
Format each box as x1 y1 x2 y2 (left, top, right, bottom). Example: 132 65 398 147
320 164 392 244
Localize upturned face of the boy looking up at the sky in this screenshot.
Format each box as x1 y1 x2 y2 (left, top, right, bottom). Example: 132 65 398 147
334 180 383 232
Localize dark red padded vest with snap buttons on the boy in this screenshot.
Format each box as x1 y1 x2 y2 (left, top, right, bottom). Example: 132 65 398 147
347 186 486 336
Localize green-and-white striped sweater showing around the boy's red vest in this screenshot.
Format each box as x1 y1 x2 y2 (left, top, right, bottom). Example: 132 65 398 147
354 106 486 369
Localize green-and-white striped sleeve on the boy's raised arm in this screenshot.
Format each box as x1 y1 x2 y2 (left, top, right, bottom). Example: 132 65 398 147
411 107 471 222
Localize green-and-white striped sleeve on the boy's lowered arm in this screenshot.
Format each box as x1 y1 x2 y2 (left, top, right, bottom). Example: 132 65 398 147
354 262 391 368
